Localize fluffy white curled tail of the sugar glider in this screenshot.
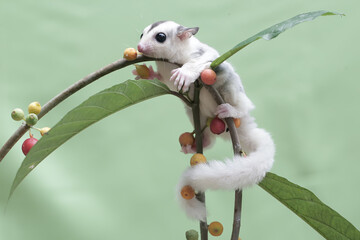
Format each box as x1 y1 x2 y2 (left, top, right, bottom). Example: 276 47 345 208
177 127 275 220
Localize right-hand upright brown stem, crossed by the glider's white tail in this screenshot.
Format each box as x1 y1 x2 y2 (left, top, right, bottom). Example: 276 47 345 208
205 85 243 240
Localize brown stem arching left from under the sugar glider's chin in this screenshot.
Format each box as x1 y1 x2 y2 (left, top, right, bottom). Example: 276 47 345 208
0 55 169 162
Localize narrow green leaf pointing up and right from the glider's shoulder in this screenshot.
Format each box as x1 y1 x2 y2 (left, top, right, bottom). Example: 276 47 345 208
210 11 344 69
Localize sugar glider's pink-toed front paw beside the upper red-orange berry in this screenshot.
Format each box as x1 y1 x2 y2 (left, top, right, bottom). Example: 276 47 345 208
170 68 198 92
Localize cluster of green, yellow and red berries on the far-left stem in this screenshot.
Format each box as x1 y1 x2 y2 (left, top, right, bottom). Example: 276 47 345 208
11 102 50 155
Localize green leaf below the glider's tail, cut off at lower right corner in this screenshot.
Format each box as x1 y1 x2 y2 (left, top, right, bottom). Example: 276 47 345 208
259 173 360 240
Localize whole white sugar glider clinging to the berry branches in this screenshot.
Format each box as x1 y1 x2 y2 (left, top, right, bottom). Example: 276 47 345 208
135 21 275 220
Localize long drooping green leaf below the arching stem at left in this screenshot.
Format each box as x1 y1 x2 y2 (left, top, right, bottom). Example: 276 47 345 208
9 80 170 198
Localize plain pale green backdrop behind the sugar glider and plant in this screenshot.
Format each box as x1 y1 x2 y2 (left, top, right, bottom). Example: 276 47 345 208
0 0 360 240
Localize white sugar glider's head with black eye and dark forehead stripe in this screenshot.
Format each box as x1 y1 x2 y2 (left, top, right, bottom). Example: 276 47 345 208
138 21 199 61
